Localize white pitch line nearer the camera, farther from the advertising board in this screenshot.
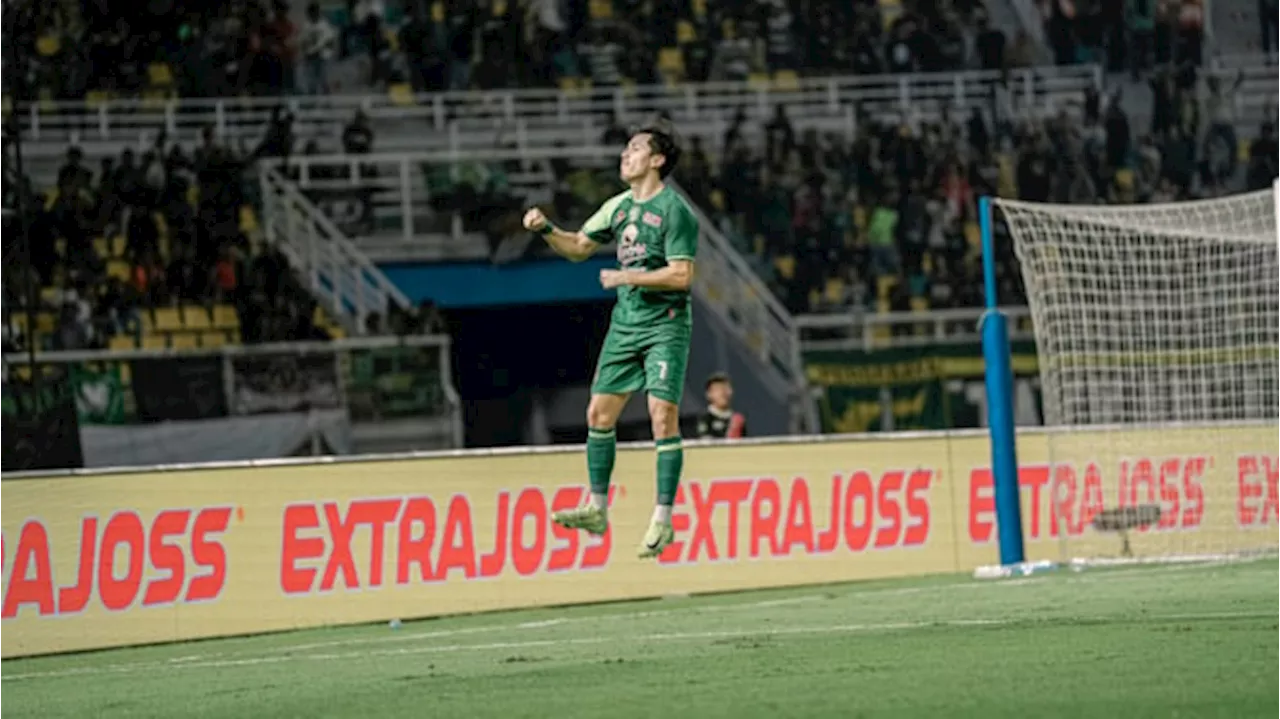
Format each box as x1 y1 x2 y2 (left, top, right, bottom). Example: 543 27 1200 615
0 612 1280 682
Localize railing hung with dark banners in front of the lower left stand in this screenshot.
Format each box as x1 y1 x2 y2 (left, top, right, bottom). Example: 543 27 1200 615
0 335 463 449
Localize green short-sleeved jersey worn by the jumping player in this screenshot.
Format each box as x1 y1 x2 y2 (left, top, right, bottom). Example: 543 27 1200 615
582 187 698 326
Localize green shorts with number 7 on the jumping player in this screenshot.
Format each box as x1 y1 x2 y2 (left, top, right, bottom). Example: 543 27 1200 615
591 319 691 404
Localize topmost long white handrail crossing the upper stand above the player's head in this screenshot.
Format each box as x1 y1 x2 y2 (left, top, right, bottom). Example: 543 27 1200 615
17 65 1098 146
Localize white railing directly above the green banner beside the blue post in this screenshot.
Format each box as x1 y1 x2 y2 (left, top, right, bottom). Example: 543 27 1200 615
795 307 1034 351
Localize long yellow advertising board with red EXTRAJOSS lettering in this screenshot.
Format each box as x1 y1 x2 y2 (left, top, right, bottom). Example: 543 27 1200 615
0 430 1280 658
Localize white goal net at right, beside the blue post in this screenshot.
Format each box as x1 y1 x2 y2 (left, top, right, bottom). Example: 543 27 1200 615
997 184 1280 563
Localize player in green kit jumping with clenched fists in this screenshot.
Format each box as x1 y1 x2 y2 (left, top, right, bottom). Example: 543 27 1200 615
525 118 698 558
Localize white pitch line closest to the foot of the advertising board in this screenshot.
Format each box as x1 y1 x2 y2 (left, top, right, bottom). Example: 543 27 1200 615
0 563 1260 682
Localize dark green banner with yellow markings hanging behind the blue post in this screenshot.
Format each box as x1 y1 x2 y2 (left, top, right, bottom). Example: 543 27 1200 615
804 342 1043 434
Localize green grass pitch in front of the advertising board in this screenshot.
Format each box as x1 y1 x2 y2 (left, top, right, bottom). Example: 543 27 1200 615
0 562 1280 719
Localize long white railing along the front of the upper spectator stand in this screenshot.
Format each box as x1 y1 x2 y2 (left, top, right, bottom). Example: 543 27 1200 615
17 65 1102 154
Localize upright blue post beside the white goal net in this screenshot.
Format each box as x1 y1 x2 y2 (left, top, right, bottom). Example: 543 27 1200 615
978 197 1027 565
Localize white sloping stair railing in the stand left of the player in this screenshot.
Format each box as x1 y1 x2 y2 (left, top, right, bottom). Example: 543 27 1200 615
259 164 411 326
